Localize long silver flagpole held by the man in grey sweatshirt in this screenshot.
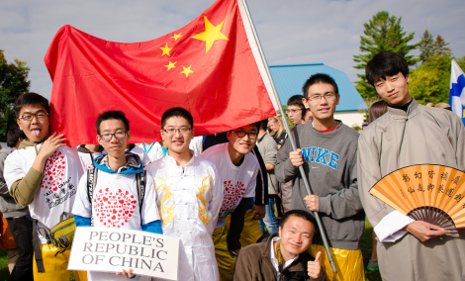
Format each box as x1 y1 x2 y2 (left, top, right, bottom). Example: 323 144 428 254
238 0 336 273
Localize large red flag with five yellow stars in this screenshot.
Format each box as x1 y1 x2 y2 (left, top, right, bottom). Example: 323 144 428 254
45 0 276 146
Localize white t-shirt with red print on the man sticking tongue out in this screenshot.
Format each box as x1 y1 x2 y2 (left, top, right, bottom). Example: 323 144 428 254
4 144 82 243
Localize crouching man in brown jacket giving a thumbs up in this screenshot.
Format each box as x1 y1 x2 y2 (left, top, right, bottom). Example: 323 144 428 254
234 210 326 281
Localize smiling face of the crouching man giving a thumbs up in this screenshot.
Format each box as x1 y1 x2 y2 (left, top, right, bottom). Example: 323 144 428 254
279 215 315 260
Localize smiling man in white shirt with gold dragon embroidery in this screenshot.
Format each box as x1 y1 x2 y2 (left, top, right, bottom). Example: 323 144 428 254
146 107 223 281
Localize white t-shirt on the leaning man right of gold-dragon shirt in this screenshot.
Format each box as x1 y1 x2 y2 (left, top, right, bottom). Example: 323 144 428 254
201 143 259 226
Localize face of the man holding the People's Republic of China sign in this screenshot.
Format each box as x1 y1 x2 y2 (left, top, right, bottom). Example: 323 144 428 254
97 119 131 158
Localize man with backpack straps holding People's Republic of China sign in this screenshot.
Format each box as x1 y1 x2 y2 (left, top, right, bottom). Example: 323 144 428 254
73 111 162 280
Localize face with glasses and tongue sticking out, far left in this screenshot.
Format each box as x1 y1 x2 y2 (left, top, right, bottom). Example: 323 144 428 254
17 104 50 143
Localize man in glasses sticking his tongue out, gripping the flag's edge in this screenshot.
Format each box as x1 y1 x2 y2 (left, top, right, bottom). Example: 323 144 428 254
4 93 85 280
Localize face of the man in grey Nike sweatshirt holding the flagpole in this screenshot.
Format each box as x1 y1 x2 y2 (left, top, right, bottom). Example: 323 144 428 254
304 83 339 122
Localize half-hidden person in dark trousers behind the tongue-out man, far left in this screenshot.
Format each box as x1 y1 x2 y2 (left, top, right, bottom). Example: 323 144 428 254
0 123 34 281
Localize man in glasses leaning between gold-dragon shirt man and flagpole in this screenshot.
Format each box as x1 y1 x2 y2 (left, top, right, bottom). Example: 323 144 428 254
201 122 261 280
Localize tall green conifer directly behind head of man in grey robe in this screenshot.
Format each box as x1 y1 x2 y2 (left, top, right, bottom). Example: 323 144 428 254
353 11 417 102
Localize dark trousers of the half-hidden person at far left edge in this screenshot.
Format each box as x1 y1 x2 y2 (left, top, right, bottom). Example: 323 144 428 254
7 216 34 281
